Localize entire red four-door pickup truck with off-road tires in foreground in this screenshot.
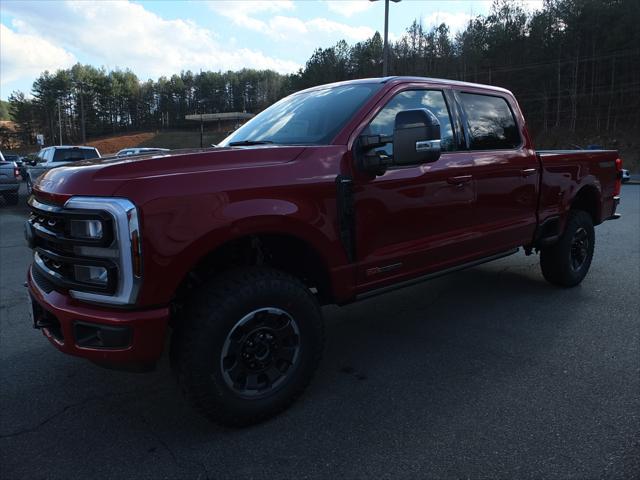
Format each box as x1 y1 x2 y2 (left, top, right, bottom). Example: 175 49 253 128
25 77 622 425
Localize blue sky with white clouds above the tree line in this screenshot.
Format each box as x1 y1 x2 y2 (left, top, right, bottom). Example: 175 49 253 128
0 0 542 100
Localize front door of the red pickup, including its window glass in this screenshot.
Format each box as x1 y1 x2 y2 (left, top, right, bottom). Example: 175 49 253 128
354 89 476 291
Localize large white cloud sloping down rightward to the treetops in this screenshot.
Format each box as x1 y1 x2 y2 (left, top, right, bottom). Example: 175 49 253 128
2 1 300 85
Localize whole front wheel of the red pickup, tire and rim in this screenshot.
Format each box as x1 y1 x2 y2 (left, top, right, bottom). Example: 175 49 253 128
172 268 323 426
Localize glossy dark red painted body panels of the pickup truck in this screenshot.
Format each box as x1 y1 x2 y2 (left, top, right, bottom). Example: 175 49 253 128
29 78 617 362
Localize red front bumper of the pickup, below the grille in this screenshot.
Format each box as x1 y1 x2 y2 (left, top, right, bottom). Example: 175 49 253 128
27 268 169 368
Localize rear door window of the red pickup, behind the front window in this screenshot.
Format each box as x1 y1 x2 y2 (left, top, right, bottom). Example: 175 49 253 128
460 93 521 150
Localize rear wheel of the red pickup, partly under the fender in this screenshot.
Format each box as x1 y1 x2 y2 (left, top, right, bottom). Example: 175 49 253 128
540 210 595 287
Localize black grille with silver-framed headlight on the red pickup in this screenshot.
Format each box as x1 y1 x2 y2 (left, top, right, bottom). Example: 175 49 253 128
25 197 142 305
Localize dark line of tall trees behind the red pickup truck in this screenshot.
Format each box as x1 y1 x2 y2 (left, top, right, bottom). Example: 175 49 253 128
3 0 640 149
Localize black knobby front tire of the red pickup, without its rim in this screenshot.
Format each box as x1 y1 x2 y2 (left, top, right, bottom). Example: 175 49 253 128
171 267 324 427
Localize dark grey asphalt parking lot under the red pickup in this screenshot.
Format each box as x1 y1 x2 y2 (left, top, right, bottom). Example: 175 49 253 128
0 185 640 479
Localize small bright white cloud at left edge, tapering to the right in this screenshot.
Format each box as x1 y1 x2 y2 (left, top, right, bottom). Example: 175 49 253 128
0 22 76 86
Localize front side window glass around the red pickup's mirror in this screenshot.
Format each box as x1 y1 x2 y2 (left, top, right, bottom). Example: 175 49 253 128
362 90 455 155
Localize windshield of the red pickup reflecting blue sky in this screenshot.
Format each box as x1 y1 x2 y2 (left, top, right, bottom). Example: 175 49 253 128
219 83 381 147
